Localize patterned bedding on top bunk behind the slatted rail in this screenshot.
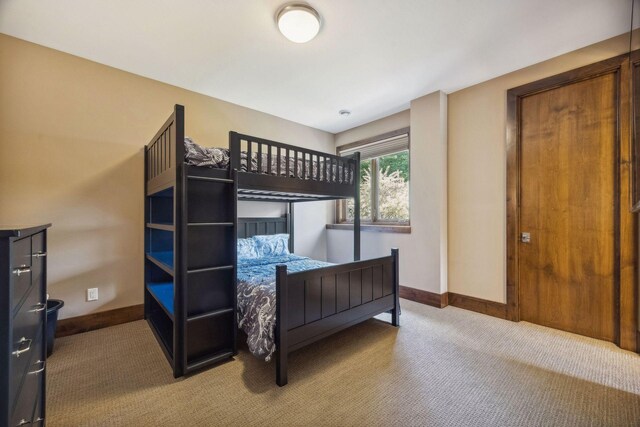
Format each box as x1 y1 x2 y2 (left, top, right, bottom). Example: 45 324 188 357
184 137 353 184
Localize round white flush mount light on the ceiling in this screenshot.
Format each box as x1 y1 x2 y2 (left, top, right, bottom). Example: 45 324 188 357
276 3 320 43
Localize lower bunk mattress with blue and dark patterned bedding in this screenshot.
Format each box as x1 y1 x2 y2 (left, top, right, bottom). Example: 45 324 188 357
238 254 333 361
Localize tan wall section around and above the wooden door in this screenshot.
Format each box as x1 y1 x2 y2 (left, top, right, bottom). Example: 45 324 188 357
448 30 640 302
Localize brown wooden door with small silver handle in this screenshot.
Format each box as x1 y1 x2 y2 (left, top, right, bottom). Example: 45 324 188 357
518 73 619 342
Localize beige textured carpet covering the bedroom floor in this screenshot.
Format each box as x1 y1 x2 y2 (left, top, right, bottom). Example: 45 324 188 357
47 300 640 426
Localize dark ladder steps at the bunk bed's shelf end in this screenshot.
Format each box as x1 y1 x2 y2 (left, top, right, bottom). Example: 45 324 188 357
183 151 237 374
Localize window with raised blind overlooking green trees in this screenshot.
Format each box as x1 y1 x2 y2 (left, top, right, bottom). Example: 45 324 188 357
337 128 410 225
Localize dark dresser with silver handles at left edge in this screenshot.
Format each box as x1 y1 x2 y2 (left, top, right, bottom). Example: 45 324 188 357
0 224 51 427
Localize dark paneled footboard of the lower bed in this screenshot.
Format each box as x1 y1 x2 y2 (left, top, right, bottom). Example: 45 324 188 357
276 249 400 386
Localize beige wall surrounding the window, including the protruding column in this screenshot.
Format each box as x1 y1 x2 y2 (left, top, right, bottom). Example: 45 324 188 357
327 92 447 293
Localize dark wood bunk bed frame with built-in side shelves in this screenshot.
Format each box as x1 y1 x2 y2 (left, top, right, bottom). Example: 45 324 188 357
144 105 400 386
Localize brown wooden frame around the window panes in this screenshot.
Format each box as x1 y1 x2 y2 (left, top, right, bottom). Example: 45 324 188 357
336 127 411 227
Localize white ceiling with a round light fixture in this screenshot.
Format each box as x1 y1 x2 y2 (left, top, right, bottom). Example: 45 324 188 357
0 0 631 133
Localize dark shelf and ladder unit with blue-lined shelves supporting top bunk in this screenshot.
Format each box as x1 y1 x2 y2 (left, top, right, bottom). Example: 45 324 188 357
144 106 237 377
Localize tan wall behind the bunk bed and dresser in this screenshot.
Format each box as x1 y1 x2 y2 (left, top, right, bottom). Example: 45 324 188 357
0 35 334 317
